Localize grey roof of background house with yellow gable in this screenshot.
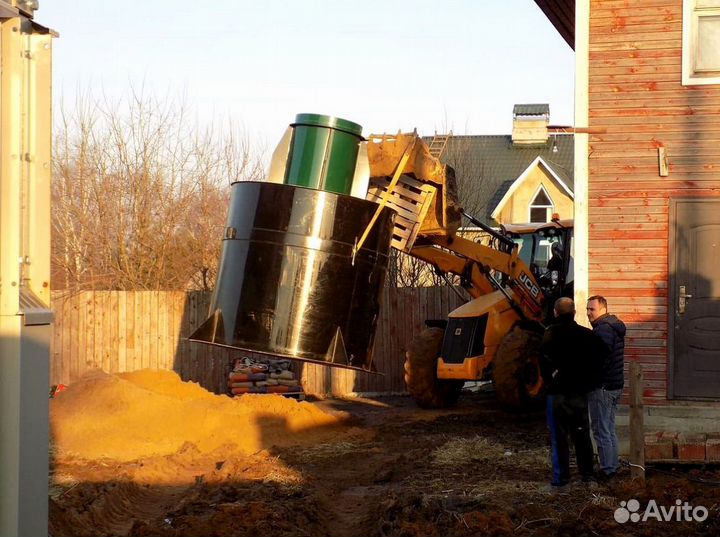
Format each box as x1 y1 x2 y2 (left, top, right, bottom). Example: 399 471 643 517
442 134 574 225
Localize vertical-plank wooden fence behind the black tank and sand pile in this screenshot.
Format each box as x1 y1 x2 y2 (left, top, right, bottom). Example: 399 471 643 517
50 287 461 395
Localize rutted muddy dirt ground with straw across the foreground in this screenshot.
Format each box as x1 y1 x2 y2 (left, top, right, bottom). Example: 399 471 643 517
50 376 720 537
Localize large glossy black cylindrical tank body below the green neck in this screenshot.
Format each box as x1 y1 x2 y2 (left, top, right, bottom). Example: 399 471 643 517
190 182 395 371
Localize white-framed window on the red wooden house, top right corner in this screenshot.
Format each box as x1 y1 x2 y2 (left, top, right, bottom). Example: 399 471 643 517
682 0 720 85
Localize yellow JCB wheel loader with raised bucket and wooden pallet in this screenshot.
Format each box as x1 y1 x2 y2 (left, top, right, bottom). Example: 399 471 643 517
368 134 573 410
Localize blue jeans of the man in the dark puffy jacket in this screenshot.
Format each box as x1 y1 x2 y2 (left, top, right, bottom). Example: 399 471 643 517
588 388 622 475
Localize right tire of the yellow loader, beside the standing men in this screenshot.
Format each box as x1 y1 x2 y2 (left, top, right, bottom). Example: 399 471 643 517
493 326 543 412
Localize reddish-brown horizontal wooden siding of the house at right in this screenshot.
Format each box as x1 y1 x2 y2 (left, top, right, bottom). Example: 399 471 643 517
588 0 720 404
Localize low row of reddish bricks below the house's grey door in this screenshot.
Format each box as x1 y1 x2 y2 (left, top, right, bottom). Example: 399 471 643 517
645 431 720 463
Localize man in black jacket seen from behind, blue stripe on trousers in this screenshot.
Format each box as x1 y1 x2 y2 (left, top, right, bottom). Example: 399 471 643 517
540 297 607 487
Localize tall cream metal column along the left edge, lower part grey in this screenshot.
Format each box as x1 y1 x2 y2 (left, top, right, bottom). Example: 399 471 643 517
0 0 53 537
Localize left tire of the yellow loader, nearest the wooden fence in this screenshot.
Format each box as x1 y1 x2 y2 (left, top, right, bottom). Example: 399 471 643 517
405 328 465 408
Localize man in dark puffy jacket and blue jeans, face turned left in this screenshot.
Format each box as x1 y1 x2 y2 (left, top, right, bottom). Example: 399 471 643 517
587 295 625 478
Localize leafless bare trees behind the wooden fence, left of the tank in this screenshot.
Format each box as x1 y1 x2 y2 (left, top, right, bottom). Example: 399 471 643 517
52 92 263 290
